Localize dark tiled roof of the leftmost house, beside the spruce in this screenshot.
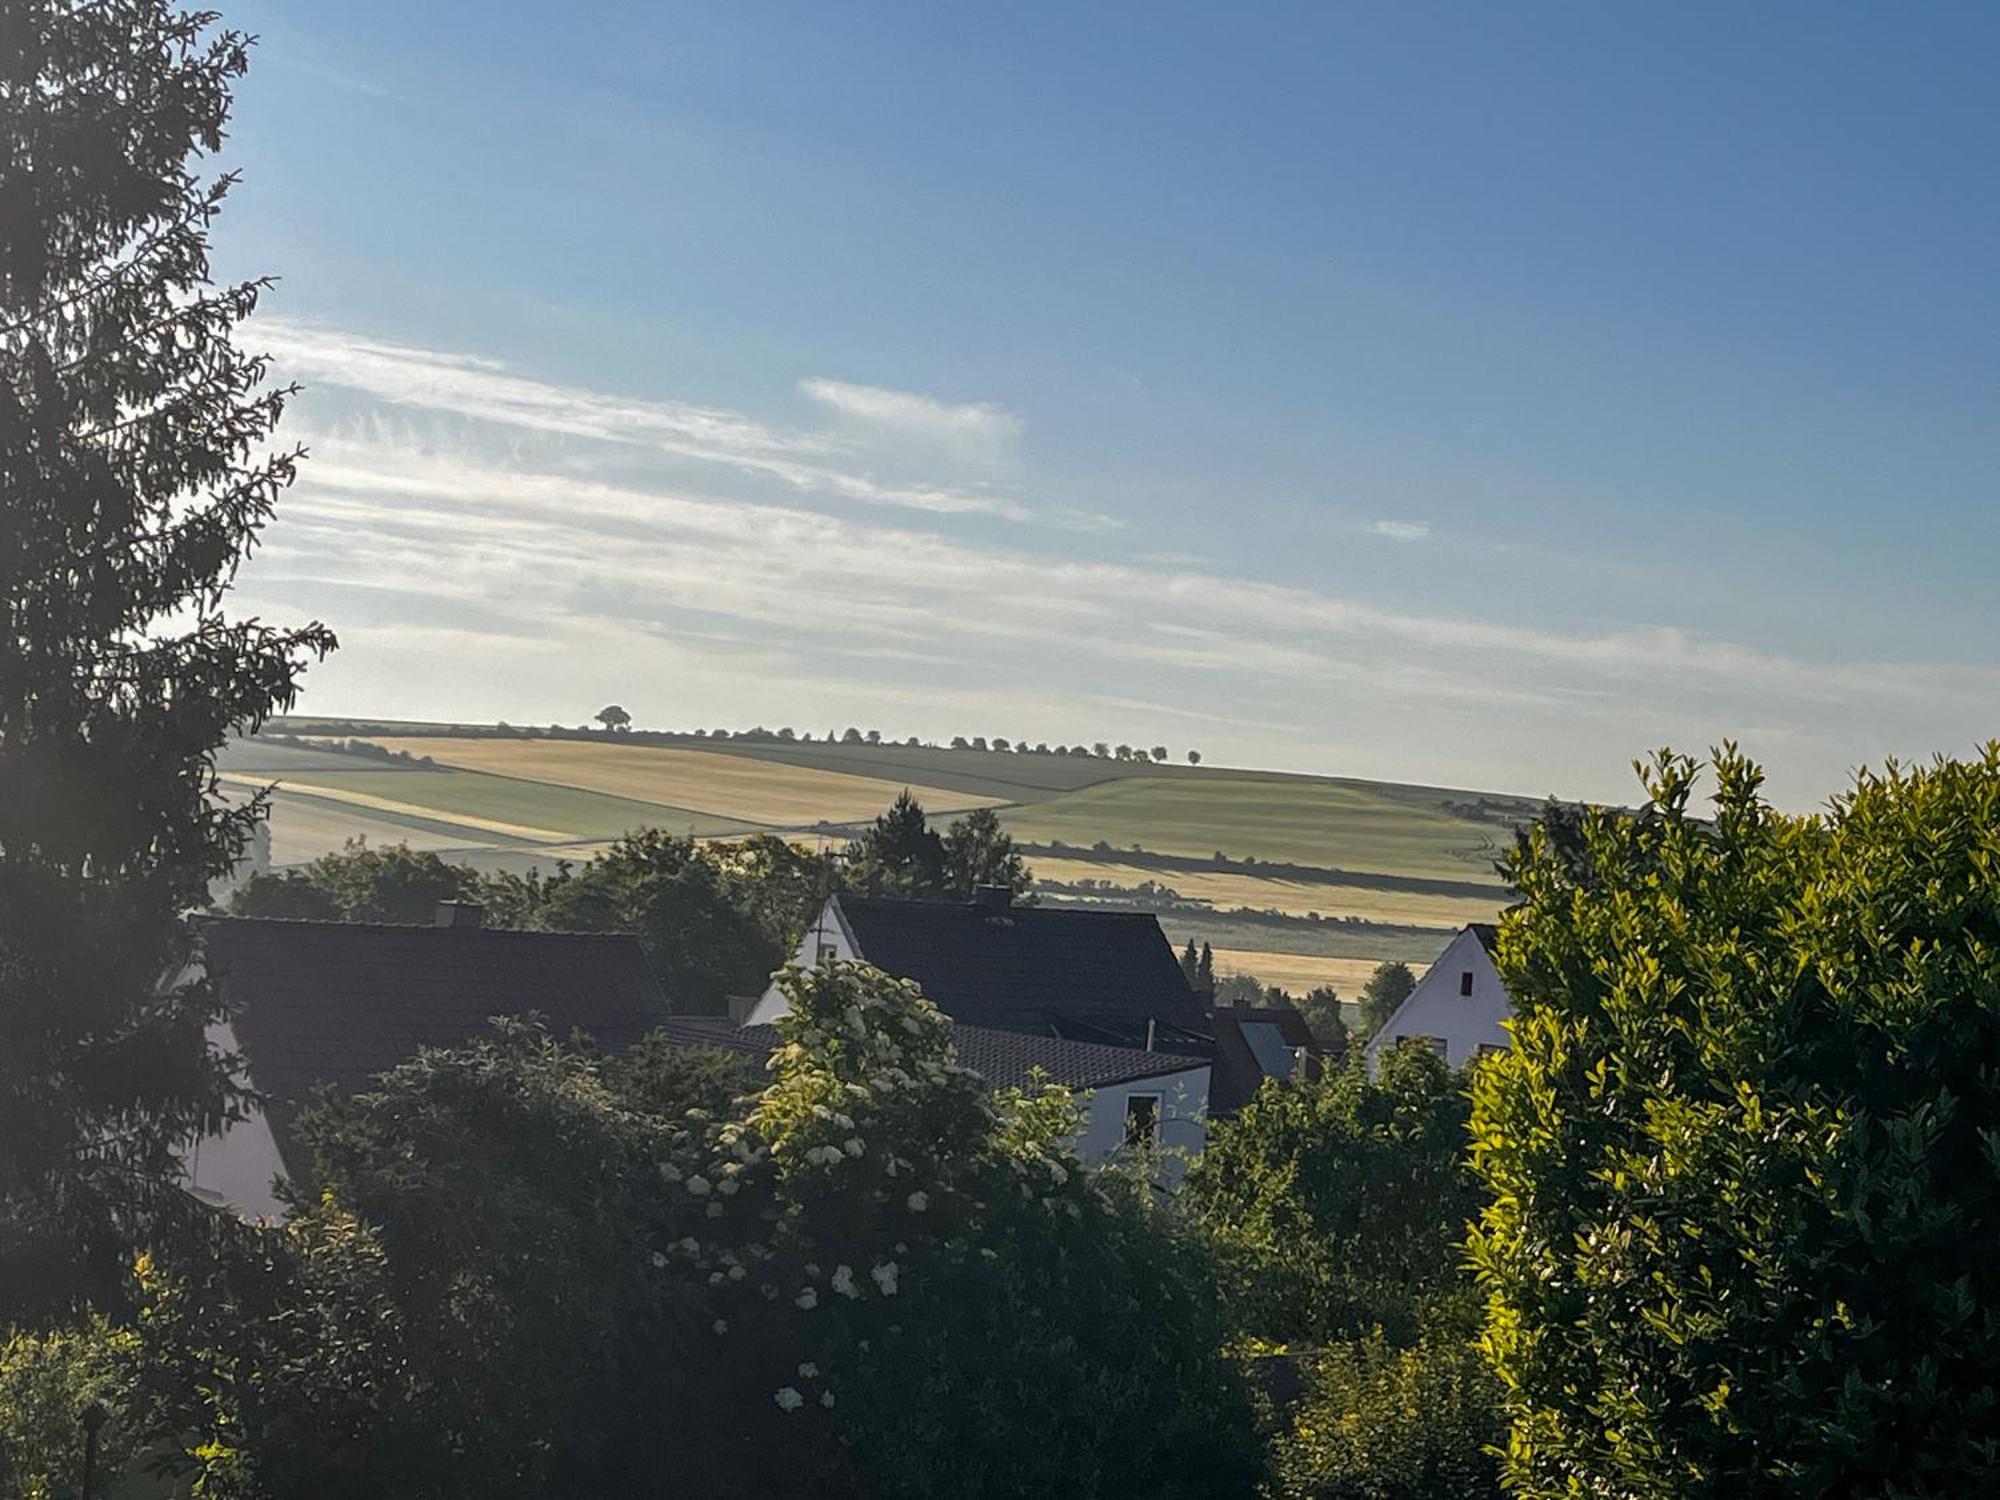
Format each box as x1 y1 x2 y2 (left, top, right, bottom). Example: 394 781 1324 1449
202 918 666 1102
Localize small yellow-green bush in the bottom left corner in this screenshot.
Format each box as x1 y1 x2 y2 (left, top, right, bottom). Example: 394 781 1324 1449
0 1318 138 1500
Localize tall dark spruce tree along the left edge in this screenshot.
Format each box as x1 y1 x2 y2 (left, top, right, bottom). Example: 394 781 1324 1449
0 0 334 1322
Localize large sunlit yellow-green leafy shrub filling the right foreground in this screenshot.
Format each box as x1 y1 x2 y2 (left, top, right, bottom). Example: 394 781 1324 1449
1474 748 2000 1496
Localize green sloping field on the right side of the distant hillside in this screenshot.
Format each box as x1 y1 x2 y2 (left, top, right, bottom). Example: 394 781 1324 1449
1004 776 1506 884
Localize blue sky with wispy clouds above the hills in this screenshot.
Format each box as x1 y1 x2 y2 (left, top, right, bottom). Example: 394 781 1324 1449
216 0 2000 806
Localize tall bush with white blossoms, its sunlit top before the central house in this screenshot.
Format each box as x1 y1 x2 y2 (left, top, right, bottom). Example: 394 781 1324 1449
750 964 1252 1496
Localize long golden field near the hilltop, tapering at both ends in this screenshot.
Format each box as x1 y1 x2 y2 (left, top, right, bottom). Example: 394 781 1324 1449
362 736 996 828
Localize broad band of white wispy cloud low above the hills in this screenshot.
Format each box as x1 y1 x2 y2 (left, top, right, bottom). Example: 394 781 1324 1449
244 320 2000 812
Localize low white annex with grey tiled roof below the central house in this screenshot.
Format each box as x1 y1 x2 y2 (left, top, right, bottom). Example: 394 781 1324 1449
660 1016 1210 1180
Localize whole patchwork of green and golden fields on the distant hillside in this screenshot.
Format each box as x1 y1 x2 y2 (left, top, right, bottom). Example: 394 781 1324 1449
246 718 1536 988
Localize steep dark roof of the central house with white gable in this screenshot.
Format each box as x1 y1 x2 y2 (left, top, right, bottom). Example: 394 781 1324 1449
836 896 1210 1054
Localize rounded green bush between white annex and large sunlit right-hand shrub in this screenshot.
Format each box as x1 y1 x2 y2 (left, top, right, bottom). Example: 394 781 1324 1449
1186 1048 1480 1344
